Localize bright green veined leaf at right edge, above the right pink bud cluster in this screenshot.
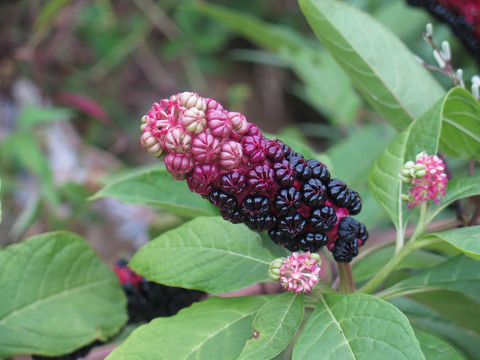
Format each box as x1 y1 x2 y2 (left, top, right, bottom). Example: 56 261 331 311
440 87 480 160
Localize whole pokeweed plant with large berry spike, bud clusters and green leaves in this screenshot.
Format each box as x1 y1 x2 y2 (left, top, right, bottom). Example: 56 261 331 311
0 0 480 359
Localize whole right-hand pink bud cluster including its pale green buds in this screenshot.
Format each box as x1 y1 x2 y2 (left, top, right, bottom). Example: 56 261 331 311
399 152 448 209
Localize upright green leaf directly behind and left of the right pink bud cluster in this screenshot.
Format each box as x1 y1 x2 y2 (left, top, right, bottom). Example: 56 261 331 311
369 91 445 231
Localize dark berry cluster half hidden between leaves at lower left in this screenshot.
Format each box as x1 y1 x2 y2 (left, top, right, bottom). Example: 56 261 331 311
114 260 204 323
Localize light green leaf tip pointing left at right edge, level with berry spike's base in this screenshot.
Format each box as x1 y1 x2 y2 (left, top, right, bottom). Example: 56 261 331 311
425 225 480 267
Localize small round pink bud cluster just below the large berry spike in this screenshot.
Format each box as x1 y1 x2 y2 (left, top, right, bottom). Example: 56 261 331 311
280 252 320 294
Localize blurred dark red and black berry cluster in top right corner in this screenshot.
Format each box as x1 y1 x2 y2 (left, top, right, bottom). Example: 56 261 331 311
407 0 480 64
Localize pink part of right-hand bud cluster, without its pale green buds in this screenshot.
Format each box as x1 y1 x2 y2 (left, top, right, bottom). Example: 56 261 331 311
407 152 448 209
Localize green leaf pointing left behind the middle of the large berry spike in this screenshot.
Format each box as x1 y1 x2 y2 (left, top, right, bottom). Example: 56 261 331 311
90 168 217 218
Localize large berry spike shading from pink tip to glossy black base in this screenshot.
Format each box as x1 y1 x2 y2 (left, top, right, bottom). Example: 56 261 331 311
141 92 368 262
